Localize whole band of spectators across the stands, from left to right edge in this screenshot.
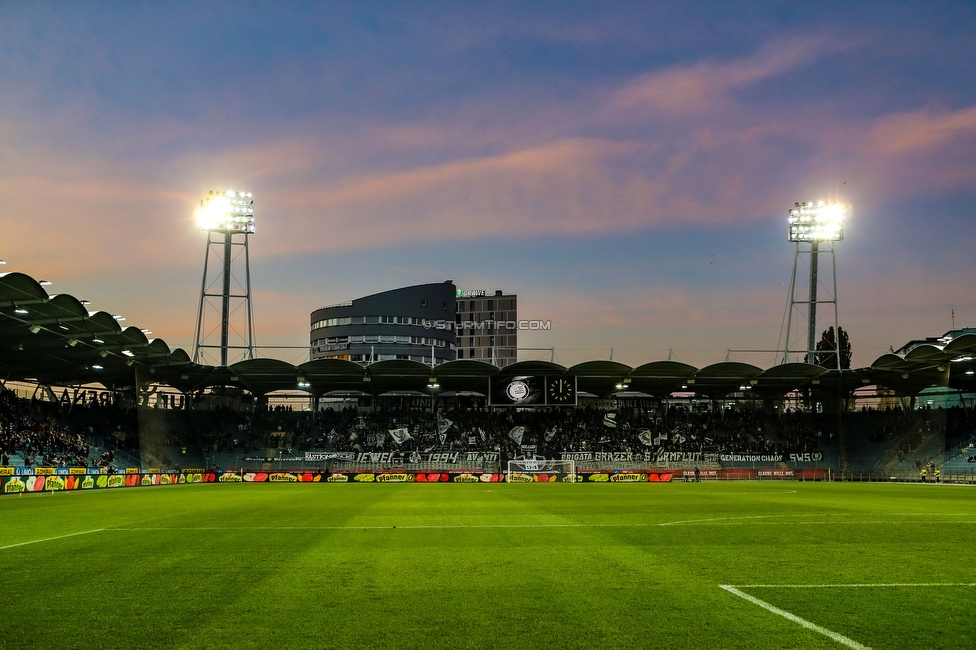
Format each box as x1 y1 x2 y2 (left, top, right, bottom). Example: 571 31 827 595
0 382 976 467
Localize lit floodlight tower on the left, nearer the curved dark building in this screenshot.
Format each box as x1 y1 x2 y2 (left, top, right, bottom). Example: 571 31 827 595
193 190 254 366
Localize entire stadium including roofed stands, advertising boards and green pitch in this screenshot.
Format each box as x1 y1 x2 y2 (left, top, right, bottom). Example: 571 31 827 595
0 235 976 648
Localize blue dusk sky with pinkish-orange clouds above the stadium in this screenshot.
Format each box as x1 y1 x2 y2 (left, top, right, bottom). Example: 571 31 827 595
0 0 976 367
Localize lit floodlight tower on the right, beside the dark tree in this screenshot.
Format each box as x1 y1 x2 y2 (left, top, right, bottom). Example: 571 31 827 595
782 201 851 370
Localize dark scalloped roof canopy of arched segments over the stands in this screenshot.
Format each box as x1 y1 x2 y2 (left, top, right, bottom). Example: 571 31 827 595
0 273 976 399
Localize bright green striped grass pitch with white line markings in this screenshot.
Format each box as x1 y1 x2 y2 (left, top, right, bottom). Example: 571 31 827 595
0 482 976 649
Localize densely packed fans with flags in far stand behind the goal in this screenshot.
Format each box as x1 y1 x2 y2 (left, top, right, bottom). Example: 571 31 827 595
298 405 835 454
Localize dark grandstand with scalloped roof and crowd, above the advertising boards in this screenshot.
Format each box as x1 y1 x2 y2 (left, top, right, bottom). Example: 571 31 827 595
0 273 976 482
